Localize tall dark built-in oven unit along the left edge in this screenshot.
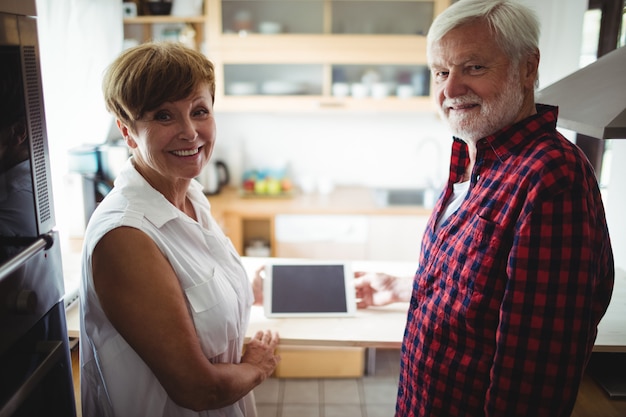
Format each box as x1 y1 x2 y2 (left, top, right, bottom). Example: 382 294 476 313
0 0 76 417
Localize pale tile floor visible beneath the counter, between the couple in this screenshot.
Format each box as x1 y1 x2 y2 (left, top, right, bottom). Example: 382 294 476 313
254 349 400 417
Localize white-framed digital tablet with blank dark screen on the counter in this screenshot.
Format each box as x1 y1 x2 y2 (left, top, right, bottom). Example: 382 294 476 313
263 261 356 317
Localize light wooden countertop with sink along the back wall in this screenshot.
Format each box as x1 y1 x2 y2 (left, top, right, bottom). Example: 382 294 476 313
207 187 431 216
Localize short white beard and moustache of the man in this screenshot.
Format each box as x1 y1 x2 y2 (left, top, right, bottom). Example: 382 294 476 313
439 71 524 142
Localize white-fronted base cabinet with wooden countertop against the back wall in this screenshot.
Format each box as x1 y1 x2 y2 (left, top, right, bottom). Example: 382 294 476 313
208 187 431 262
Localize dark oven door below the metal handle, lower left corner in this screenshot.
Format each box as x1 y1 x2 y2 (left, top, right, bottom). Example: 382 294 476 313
0 232 76 417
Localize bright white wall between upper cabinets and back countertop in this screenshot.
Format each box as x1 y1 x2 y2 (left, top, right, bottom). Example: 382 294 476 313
214 112 451 188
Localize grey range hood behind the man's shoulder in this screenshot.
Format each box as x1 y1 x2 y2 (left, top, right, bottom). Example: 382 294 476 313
536 47 626 139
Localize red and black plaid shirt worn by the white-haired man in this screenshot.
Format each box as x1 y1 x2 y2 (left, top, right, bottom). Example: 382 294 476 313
396 105 614 417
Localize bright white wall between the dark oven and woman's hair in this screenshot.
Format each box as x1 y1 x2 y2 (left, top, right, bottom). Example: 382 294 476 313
37 0 123 238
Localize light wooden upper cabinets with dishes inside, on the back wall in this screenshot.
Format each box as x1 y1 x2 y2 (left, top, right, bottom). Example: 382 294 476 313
124 0 451 112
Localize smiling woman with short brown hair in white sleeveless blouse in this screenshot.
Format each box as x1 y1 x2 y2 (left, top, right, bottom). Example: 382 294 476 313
80 43 279 417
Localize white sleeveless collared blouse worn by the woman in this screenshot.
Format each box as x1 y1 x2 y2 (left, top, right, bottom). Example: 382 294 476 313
80 160 256 417
